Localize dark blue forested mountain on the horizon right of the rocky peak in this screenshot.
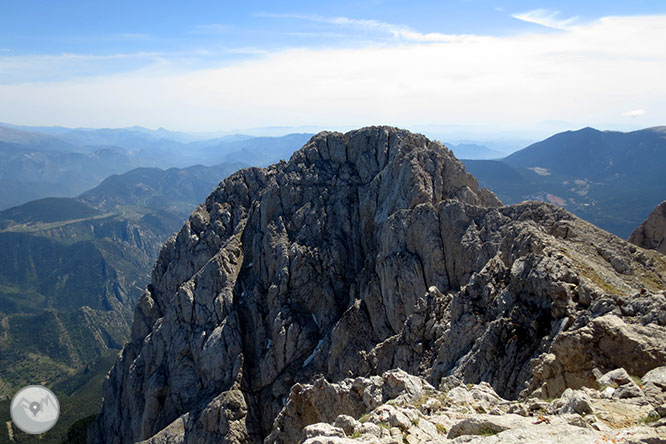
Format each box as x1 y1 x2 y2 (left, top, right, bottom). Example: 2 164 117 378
464 127 666 238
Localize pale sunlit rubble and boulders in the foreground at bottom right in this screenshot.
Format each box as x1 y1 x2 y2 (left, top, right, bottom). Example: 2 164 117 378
274 367 666 444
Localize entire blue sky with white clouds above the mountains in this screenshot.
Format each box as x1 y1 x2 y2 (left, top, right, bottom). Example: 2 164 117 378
0 0 666 138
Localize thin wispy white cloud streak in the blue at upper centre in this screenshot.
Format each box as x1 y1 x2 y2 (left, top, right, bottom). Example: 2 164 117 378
260 14 472 43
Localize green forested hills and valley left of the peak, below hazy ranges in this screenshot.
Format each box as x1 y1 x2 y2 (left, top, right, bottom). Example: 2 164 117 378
0 163 246 442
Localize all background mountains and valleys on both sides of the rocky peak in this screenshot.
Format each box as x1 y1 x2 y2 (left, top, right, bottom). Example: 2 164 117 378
0 126 666 442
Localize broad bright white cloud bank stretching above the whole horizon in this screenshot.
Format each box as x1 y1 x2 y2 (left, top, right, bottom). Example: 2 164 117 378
0 16 666 130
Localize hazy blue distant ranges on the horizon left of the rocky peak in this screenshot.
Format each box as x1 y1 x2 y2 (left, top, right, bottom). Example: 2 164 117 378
0 124 311 210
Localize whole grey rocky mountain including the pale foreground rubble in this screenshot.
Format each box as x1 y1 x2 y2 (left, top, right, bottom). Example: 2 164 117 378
89 127 666 444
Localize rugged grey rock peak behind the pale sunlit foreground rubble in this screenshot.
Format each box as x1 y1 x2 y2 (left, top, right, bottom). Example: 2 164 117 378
90 127 666 443
